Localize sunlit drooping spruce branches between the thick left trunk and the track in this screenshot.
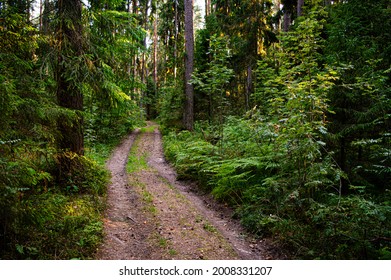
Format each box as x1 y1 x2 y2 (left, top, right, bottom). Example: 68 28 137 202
82 8 145 143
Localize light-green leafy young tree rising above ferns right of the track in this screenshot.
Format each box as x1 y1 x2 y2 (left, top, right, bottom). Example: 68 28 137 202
253 5 340 197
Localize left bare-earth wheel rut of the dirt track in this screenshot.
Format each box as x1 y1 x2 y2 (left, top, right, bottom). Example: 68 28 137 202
96 130 165 260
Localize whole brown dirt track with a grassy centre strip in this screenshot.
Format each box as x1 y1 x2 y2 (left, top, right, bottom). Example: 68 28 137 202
96 122 284 260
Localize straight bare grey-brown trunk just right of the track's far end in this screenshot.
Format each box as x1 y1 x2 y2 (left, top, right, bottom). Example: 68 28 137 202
183 0 194 131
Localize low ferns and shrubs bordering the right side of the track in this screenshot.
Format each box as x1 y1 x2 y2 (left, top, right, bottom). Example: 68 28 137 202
164 117 391 259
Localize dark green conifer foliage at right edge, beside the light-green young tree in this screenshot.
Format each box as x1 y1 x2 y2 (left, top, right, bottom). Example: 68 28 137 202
325 0 391 192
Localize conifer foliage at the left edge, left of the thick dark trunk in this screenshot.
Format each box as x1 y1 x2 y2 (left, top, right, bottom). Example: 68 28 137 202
0 9 61 258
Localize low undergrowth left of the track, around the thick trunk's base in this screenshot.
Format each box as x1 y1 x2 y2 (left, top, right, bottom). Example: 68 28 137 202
0 121 139 260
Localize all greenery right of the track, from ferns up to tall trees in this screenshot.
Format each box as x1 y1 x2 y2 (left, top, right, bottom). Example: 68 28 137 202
162 1 391 259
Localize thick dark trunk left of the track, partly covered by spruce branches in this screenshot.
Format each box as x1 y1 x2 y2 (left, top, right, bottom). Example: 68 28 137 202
56 0 84 155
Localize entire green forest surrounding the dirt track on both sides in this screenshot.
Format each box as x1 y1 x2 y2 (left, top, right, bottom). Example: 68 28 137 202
0 0 391 259
